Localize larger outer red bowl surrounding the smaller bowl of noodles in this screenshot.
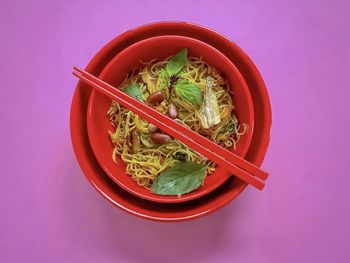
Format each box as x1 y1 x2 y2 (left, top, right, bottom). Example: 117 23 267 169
70 22 271 221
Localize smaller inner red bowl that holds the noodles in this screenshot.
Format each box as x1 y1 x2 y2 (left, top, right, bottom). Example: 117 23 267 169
87 36 254 203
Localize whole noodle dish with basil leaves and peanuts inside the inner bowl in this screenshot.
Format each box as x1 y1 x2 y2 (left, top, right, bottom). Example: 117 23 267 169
107 48 248 195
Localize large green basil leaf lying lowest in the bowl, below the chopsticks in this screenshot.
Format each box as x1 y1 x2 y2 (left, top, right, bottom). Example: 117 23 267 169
151 161 207 195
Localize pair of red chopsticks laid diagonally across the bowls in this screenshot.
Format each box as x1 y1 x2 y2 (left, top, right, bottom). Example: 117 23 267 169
73 67 268 190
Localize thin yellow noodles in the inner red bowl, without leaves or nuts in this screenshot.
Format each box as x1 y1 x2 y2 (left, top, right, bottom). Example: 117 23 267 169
107 58 248 188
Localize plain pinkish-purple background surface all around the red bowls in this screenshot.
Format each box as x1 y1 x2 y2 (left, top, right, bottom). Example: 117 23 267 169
0 0 350 263
